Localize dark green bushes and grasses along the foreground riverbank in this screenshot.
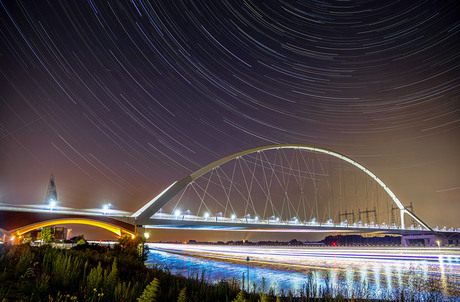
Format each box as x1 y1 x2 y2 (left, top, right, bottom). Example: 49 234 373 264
0 237 452 302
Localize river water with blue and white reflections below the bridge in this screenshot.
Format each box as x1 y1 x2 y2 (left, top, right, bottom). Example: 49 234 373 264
147 245 460 301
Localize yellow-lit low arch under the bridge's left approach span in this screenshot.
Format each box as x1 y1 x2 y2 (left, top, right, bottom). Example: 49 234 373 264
10 218 135 236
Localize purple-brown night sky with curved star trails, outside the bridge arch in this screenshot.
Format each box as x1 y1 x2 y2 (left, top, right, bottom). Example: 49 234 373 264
0 0 460 238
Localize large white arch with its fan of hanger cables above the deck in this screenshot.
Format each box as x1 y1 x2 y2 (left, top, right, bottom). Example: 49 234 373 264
133 144 432 231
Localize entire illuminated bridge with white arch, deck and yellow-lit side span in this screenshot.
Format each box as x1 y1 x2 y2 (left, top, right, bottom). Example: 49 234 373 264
0 144 459 245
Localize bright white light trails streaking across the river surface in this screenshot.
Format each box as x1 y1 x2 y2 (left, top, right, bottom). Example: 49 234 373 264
148 243 460 297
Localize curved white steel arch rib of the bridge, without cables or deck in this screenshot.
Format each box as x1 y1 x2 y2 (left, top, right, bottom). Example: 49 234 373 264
132 144 431 230
